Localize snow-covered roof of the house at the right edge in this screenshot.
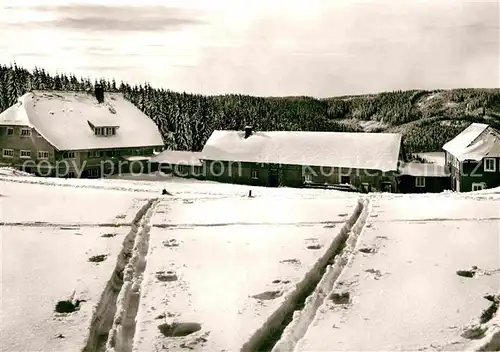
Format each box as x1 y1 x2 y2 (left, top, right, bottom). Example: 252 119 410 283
443 123 500 161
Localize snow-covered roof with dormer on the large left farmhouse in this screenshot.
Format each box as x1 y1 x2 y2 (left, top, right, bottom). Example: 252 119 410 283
0 91 164 150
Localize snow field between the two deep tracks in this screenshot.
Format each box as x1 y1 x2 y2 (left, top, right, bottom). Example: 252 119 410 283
134 198 357 351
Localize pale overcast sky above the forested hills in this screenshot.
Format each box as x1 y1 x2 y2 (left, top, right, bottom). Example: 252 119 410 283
0 0 500 97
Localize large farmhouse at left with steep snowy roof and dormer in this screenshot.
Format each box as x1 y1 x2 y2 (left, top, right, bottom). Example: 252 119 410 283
0 85 164 177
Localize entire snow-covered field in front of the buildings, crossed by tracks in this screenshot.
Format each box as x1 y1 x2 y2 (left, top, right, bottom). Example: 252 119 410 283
0 169 500 352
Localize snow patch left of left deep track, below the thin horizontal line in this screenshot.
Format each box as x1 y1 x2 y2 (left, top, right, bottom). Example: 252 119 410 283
0 226 127 352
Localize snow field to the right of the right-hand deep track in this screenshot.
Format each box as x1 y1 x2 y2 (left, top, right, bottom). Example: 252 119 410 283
296 196 500 351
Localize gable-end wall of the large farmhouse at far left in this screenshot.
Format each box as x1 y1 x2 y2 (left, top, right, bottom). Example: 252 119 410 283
0 125 55 172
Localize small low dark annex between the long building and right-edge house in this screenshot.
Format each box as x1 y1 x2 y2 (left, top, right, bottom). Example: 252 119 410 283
398 162 451 193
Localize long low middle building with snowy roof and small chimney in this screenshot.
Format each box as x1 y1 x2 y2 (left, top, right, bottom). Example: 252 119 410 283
197 127 405 192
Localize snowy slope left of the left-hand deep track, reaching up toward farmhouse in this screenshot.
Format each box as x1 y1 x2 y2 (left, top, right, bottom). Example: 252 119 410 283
0 181 150 351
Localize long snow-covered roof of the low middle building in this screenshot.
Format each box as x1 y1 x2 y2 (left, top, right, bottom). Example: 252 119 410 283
202 131 401 171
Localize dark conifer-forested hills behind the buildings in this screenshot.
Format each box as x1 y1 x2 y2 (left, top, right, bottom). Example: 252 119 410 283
0 65 500 152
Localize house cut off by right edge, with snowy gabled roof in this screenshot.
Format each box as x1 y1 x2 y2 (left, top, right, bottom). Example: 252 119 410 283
443 123 500 192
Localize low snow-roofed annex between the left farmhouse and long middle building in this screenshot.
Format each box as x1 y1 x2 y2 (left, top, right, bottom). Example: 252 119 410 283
149 150 204 180
